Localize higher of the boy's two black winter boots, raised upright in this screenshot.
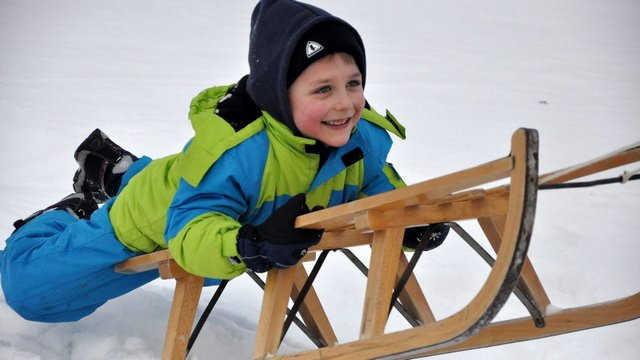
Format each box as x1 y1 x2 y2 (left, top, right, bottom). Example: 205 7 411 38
73 129 138 204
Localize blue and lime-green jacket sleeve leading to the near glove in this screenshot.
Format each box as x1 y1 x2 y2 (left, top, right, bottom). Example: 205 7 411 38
165 152 260 279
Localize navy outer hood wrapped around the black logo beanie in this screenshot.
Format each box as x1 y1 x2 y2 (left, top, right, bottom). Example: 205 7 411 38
247 0 366 134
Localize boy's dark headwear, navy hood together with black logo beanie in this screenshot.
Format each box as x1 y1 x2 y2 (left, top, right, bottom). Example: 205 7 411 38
247 0 366 135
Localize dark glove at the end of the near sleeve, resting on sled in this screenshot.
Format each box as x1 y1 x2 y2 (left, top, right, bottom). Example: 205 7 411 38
237 193 324 272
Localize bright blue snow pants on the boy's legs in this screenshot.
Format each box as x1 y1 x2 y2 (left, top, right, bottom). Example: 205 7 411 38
0 157 158 322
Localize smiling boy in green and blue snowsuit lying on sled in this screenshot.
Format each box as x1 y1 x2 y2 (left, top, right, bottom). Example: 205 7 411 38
0 0 446 322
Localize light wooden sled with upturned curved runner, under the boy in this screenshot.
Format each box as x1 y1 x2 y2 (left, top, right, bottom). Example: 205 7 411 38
116 129 640 359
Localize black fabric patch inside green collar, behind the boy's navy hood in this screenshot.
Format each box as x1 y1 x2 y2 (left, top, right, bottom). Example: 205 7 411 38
215 75 262 131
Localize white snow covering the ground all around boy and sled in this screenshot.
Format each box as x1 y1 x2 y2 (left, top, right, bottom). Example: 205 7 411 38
0 0 640 360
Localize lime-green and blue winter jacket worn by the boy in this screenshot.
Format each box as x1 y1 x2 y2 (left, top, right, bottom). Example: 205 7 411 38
109 86 405 279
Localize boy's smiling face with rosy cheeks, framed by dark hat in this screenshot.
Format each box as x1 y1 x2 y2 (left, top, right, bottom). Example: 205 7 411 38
289 53 365 147
